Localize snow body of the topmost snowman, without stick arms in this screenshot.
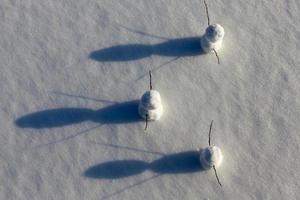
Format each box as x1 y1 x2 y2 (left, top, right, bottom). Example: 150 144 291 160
200 24 225 53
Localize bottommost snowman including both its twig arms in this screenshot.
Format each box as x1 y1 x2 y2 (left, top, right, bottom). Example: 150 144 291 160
199 121 223 186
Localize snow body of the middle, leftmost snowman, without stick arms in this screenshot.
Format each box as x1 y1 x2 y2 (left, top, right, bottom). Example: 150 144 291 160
138 90 163 120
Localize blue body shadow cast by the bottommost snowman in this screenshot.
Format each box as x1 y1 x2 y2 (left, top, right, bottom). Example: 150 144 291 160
83 151 204 179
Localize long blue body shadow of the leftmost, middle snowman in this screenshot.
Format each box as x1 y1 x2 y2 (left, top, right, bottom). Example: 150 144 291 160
15 100 142 129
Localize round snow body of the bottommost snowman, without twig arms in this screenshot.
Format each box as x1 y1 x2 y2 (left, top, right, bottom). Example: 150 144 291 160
200 146 223 169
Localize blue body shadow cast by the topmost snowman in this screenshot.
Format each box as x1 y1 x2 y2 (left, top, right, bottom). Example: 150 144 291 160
89 37 204 62
